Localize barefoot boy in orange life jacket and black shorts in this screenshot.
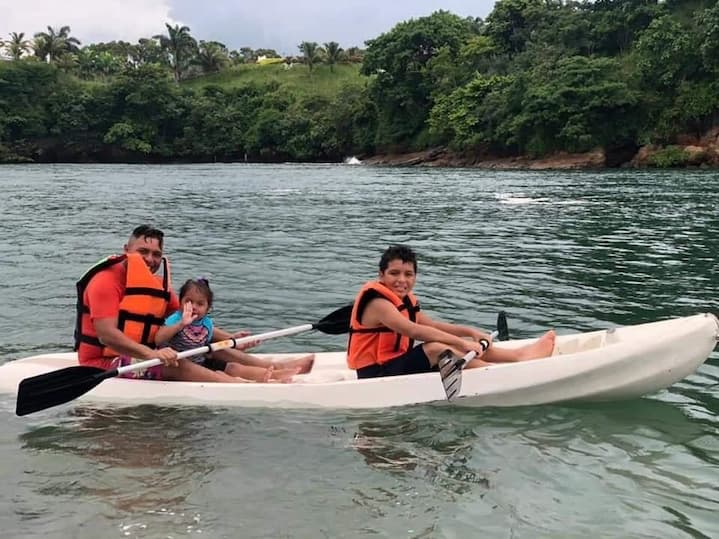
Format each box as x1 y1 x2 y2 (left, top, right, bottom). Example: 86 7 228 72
347 245 555 378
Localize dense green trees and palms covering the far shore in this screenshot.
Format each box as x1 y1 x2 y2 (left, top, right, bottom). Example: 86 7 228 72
0 0 719 165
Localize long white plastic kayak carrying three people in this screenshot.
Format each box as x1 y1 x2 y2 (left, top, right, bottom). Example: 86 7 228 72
0 313 719 409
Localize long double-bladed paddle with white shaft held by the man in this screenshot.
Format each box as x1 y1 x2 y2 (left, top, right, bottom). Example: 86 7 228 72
15 305 352 416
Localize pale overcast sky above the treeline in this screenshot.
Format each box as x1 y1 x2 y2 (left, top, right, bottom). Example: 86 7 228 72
0 0 494 54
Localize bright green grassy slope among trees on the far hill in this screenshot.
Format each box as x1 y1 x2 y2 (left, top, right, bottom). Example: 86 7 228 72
182 64 367 96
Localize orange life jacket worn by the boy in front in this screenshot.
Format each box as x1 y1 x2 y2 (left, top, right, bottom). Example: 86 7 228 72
347 281 419 369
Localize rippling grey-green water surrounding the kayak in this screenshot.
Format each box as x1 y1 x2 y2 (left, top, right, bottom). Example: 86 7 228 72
0 164 719 538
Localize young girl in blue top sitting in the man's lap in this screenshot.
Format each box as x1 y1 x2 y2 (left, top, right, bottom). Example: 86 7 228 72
155 278 302 382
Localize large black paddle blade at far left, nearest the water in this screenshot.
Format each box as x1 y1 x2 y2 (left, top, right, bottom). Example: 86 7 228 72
15 366 110 415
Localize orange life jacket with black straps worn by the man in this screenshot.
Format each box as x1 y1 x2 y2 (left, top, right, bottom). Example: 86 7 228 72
75 253 170 357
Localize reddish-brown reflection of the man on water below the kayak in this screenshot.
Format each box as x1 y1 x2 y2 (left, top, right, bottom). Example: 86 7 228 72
19 406 216 533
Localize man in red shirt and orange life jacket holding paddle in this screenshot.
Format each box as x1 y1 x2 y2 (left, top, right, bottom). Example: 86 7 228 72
75 225 256 382
